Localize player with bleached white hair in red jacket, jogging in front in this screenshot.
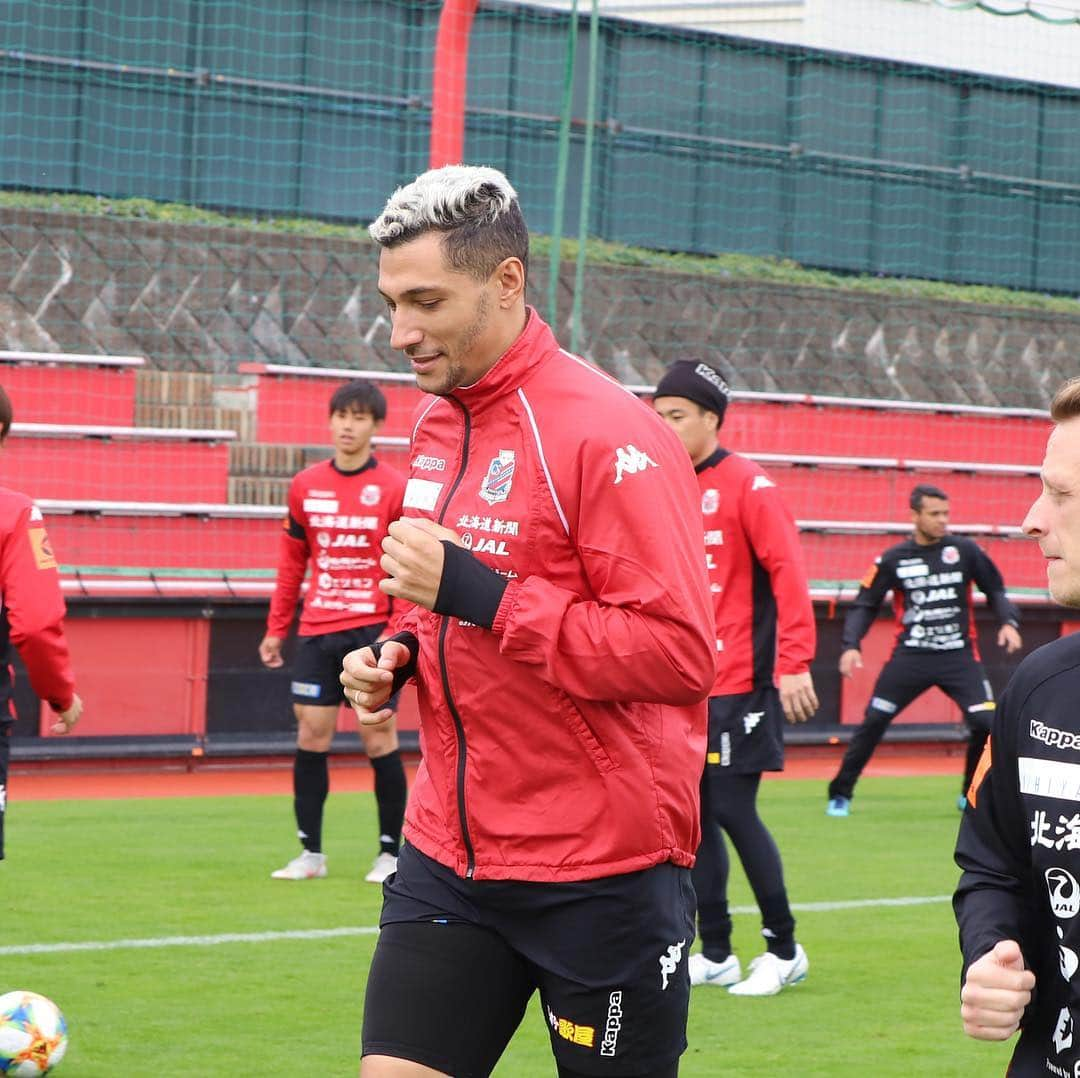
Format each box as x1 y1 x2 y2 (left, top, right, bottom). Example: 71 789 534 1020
341 166 715 1078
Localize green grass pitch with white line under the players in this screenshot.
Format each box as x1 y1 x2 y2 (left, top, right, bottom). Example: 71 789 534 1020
0 776 1010 1078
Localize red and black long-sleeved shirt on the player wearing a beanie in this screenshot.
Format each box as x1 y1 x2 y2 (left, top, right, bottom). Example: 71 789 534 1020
694 448 818 697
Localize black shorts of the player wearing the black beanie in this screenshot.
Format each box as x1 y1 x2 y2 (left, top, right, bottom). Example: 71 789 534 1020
705 685 784 776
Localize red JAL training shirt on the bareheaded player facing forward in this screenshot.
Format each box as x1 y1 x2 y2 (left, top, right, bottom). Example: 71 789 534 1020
267 457 405 637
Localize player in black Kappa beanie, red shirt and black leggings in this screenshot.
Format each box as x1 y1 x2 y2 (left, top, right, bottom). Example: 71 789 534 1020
652 360 818 996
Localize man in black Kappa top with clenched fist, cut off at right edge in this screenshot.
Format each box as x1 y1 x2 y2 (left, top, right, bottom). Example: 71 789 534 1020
953 379 1080 1078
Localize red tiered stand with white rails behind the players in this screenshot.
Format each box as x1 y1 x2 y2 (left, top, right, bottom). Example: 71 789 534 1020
0 353 1047 755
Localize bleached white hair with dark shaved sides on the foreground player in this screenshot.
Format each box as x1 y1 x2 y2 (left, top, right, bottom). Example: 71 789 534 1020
368 164 529 281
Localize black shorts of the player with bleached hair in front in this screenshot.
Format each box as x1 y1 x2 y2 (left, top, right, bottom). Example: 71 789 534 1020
363 844 696 1078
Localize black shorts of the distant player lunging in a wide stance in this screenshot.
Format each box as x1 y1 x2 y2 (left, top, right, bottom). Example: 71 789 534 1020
866 648 997 730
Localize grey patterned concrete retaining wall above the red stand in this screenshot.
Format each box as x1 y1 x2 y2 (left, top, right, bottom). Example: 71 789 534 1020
0 211 1080 407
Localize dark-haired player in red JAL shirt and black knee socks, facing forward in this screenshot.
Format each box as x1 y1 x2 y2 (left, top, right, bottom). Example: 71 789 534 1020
259 379 406 884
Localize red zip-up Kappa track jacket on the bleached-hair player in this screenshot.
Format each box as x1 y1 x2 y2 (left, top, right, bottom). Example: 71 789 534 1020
395 309 715 881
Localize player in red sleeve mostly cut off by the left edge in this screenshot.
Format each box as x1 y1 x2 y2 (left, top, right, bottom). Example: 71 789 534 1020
0 387 82 861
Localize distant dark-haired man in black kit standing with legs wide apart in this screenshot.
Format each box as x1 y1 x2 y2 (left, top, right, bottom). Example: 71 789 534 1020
825 484 1022 816
